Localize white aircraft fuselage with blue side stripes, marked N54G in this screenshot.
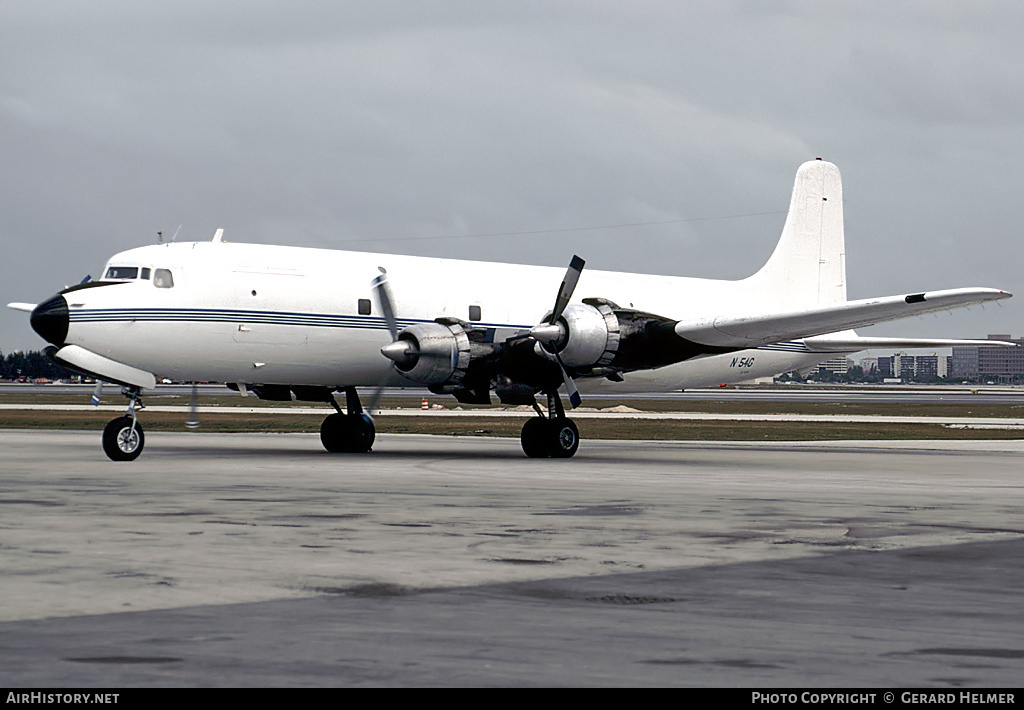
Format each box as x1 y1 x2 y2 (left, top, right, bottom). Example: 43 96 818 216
34 242 834 391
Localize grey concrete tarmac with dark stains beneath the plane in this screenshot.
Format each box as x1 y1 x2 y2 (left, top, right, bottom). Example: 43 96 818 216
0 430 1024 688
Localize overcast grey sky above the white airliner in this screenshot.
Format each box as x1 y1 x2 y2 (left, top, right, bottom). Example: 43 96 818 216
0 0 1024 352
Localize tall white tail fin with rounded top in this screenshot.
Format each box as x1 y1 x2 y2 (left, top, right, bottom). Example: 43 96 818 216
745 159 846 308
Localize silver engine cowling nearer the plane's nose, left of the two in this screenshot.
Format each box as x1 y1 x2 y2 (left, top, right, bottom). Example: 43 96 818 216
394 322 471 388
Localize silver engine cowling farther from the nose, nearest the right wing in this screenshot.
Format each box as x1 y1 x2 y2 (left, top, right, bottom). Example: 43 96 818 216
536 303 621 368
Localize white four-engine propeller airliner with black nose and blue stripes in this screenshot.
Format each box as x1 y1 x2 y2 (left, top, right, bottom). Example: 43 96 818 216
9 160 1011 460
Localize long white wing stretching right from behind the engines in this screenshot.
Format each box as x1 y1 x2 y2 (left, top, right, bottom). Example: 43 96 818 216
675 288 1013 350
